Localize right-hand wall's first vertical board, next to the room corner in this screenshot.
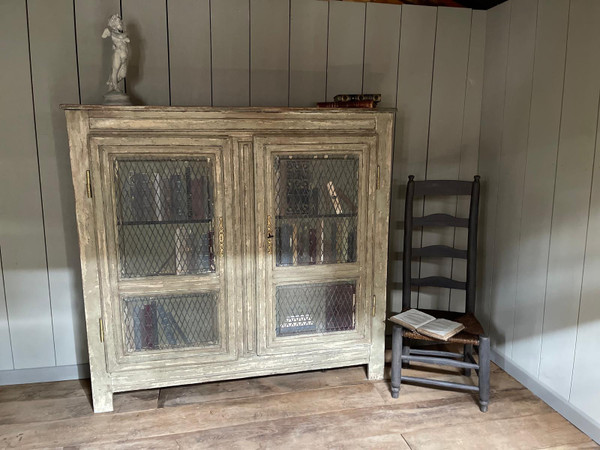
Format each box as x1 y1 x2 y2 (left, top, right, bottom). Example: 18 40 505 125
476 2 511 334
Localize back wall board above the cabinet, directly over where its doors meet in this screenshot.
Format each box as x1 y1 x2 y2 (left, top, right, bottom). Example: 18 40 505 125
211 0 250 106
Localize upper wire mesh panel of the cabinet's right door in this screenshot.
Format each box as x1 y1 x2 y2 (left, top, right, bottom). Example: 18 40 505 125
274 155 359 266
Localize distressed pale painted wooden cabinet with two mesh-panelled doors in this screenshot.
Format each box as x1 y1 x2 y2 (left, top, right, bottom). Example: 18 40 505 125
64 105 393 412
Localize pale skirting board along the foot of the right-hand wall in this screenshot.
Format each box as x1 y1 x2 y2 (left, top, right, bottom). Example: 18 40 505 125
492 349 600 444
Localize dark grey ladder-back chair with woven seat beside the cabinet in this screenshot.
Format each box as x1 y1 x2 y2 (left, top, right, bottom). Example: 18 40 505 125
392 175 490 412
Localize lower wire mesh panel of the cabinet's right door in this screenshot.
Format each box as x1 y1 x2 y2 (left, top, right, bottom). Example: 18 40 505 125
275 281 356 336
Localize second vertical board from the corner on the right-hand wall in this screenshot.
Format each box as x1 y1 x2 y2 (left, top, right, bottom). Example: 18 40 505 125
490 0 538 356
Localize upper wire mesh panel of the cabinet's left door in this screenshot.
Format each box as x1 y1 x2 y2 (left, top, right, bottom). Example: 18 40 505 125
114 157 215 278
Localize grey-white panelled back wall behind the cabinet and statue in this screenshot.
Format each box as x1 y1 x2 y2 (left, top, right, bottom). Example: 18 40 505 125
0 0 485 384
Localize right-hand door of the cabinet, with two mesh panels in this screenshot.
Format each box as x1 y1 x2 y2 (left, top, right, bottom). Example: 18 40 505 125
255 136 376 354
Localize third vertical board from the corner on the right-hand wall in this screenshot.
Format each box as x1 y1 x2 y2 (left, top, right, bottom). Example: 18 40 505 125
512 0 569 377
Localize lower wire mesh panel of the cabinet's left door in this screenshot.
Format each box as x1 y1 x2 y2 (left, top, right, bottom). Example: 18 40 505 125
122 292 219 353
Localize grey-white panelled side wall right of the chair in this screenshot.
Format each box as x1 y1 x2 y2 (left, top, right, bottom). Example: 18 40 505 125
478 0 600 441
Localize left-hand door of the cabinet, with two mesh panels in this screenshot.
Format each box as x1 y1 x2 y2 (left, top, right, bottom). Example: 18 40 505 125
92 138 235 371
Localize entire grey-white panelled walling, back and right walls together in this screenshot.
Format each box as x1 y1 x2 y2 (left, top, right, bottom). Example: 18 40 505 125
0 0 600 439
